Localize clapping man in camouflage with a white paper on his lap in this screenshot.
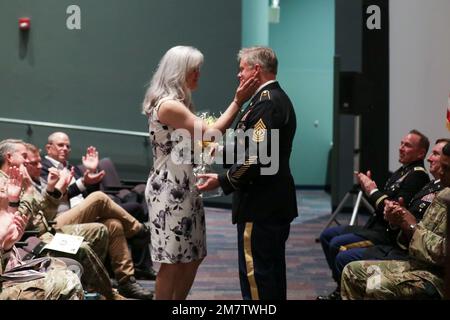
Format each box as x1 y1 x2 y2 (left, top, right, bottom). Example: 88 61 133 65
21 143 124 300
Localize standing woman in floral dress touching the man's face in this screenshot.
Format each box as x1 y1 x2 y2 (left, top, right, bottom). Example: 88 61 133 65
143 46 258 300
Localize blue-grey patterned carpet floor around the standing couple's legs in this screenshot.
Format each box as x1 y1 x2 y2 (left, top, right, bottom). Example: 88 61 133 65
140 190 364 300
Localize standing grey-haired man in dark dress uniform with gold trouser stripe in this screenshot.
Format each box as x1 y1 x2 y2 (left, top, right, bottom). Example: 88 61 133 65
199 47 298 300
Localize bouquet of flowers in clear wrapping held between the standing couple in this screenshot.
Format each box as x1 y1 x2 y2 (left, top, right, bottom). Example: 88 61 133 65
194 112 223 198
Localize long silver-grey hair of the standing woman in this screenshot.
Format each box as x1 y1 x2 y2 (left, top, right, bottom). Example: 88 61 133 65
142 46 203 114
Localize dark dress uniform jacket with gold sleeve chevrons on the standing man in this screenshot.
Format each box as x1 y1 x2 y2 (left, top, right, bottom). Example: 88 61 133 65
219 82 298 223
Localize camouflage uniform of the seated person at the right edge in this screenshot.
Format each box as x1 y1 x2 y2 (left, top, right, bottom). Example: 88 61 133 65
341 188 450 299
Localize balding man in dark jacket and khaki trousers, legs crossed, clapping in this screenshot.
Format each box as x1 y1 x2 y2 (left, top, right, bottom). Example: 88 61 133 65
41 132 153 300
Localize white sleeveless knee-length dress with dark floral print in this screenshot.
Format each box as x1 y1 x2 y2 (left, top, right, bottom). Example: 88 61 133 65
145 99 206 264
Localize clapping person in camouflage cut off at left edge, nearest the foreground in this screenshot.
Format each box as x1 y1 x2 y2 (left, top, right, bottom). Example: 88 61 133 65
0 164 84 300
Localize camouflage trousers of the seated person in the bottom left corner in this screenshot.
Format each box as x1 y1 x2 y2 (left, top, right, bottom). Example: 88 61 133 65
0 249 84 300
